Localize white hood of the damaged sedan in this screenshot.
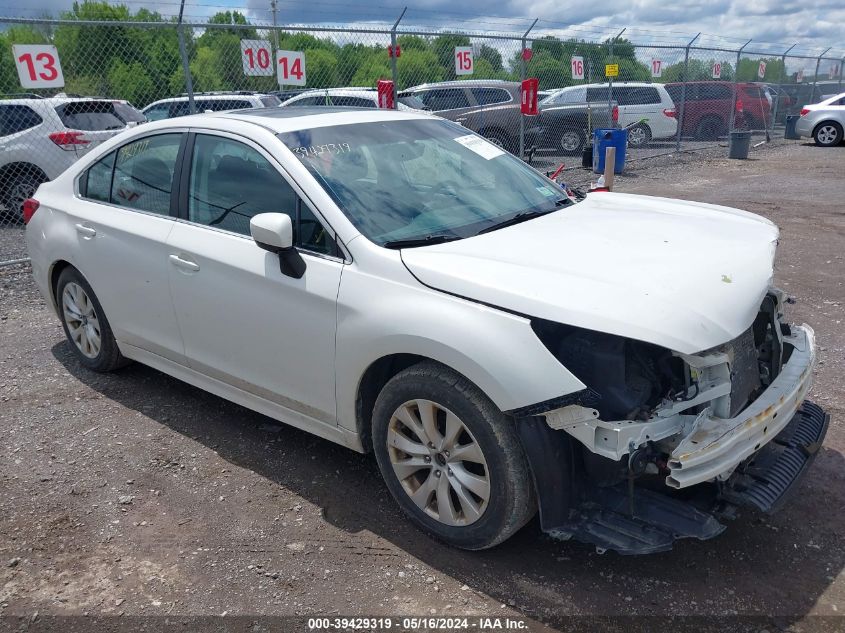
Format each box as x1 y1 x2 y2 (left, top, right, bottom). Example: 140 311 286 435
402 193 778 354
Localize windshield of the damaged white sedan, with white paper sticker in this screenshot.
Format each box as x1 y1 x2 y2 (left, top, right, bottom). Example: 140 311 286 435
279 119 569 246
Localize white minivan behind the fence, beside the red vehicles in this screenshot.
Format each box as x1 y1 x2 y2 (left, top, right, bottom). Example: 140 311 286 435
541 81 678 147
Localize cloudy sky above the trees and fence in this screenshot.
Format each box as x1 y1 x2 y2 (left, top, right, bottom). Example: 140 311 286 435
0 0 845 56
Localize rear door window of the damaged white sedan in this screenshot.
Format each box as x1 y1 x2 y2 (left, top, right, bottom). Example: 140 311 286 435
110 134 182 215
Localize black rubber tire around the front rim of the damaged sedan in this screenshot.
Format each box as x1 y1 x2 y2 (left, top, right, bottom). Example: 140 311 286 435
373 361 537 550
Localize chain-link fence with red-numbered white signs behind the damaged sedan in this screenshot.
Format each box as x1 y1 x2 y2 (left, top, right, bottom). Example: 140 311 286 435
0 9 843 230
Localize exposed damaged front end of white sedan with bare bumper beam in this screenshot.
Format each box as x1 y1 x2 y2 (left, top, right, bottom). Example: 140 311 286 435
512 289 829 554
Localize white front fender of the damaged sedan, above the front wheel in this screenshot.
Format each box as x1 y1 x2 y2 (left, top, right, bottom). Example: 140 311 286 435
336 265 584 430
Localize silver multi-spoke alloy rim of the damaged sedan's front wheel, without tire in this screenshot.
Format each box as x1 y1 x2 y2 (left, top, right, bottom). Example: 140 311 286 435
387 400 491 526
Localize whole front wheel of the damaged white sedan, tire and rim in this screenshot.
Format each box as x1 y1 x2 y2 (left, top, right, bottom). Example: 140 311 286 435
373 362 536 550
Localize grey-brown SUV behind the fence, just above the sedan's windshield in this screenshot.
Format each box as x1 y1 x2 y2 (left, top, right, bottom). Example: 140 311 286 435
399 79 522 152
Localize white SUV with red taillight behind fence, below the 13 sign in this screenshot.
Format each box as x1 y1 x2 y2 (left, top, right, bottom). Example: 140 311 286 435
0 95 145 221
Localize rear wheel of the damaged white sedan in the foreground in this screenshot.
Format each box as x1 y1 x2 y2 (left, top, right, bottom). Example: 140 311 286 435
56 267 128 372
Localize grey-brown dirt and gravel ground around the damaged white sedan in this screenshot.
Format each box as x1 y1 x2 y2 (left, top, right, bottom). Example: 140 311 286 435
0 143 845 631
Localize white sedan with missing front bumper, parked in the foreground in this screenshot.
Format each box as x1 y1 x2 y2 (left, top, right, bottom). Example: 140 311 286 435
26 108 827 553
